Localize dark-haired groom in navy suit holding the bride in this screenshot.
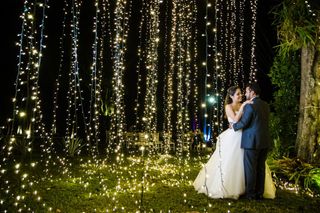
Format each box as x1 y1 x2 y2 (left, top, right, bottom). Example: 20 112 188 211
233 83 271 199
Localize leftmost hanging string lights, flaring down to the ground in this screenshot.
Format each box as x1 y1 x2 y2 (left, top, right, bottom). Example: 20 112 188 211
0 0 51 212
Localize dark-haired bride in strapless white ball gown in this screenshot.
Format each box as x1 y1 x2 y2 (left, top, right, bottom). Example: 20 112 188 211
193 86 275 199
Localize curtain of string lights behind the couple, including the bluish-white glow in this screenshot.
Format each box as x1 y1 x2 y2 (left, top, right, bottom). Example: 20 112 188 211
203 0 257 140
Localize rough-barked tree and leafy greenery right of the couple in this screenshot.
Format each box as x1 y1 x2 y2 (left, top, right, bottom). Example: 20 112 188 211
270 0 320 162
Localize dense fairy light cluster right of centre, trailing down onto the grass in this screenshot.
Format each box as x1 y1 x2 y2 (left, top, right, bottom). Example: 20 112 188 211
165 1 197 206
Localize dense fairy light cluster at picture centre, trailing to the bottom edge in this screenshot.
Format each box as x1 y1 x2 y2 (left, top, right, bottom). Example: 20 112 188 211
132 0 161 208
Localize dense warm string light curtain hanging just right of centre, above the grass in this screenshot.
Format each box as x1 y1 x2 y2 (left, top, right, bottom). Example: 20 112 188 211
163 1 197 152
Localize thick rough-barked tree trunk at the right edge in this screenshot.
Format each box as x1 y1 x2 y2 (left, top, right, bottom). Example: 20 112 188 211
296 46 320 163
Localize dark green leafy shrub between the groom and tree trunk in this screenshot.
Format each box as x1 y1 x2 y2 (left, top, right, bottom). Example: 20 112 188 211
269 52 300 157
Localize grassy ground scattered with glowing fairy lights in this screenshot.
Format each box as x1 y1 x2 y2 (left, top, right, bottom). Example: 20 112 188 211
0 153 320 212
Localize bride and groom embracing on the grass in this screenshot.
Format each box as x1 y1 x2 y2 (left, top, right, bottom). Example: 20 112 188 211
193 83 275 200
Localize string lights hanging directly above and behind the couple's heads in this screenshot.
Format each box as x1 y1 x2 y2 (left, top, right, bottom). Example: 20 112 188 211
210 0 257 140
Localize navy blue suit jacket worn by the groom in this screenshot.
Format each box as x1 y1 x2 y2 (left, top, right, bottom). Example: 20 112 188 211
233 97 271 149
